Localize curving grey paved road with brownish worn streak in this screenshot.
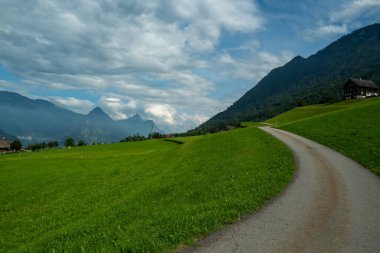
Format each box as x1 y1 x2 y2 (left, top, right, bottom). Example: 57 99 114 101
181 127 380 253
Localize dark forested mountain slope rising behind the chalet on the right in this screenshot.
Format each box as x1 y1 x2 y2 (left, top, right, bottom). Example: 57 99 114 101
198 24 380 131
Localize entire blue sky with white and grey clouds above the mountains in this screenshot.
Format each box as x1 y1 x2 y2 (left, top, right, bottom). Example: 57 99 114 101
0 0 380 132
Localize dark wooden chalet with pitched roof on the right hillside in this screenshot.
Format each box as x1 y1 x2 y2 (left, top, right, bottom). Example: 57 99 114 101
343 78 379 99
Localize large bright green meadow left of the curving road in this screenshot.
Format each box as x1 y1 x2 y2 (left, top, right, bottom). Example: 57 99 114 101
0 127 295 252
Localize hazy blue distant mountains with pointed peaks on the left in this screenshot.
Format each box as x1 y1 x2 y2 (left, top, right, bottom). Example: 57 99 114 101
0 91 162 145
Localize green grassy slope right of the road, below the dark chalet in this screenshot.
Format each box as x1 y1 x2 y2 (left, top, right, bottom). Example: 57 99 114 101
265 98 380 175
